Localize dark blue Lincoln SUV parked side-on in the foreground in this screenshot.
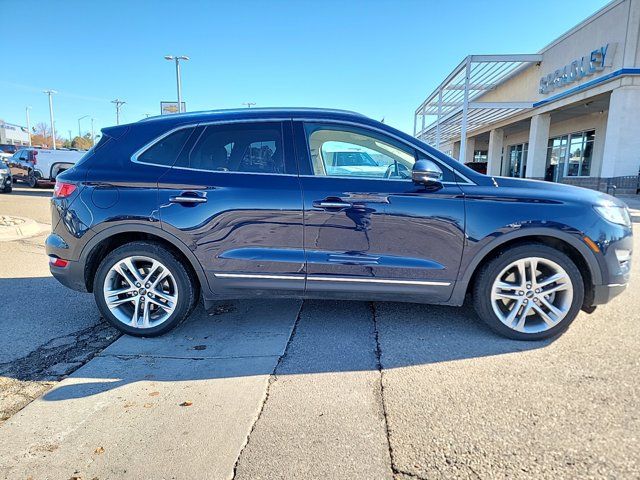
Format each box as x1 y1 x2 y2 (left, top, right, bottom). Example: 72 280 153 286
46 109 632 340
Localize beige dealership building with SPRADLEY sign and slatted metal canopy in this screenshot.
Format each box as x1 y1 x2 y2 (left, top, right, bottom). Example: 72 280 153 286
414 0 640 193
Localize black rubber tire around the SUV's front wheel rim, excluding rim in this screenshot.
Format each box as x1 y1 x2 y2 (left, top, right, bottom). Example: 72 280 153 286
473 243 584 340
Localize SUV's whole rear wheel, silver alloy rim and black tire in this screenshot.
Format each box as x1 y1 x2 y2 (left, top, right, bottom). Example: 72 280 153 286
93 242 197 337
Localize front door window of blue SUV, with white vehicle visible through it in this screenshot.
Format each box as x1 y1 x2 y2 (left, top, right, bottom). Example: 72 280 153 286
305 124 415 179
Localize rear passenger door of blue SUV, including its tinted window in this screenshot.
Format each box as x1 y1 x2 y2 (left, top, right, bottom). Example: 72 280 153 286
158 121 305 297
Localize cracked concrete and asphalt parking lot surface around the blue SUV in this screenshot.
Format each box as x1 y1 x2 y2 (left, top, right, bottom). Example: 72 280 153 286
0 188 640 479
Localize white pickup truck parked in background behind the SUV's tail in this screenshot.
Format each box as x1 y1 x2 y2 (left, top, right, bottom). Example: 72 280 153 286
8 147 86 188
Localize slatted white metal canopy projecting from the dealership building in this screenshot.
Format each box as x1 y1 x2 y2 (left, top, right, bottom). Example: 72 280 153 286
413 54 542 162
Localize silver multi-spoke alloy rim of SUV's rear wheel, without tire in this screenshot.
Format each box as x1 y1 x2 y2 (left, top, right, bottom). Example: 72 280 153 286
103 256 178 328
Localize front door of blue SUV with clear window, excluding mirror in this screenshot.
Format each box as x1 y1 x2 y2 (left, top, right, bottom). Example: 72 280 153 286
295 122 464 302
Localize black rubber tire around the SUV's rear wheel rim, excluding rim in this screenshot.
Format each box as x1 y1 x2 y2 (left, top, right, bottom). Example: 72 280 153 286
93 241 199 337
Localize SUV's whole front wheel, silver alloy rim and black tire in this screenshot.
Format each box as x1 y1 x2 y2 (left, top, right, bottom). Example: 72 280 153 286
473 244 584 340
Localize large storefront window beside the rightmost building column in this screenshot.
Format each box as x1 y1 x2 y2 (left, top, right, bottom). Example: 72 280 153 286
544 130 595 182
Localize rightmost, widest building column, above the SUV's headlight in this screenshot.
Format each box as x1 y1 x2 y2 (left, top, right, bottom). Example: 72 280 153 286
591 86 640 178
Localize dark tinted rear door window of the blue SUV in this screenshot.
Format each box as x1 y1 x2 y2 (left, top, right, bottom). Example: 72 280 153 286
175 122 285 174
